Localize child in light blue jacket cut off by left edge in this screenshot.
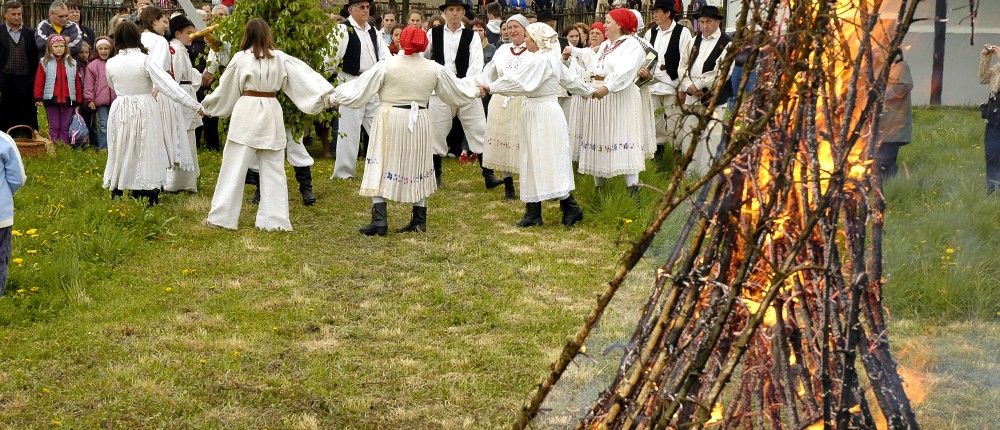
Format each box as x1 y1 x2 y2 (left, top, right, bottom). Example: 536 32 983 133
0 131 27 297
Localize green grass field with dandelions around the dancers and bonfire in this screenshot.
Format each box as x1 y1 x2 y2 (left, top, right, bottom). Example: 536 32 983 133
0 106 1000 429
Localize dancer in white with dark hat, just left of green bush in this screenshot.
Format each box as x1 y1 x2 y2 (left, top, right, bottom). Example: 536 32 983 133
163 15 201 193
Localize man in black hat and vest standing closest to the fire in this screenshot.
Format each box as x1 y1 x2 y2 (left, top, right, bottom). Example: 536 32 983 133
678 6 732 173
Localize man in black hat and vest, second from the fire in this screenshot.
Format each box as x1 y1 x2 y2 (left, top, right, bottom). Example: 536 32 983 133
639 0 691 153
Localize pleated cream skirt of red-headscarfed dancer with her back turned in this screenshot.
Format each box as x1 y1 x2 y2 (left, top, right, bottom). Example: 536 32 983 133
360 103 437 203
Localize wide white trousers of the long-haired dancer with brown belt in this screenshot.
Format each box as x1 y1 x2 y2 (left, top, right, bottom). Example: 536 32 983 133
208 142 292 230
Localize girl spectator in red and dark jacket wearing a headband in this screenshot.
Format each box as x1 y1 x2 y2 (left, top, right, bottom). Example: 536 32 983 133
35 34 83 142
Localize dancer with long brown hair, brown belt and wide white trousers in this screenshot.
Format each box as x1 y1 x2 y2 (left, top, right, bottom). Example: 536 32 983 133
202 18 333 230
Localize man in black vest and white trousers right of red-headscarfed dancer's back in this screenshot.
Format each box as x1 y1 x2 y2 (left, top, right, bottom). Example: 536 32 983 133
424 0 503 188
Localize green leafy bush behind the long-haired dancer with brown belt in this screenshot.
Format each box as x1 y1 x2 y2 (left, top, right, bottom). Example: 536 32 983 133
213 0 337 138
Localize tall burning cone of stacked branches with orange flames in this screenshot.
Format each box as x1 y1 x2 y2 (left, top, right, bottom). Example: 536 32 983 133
514 0 917 429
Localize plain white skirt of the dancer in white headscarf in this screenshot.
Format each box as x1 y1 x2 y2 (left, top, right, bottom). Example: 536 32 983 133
518 96 576 203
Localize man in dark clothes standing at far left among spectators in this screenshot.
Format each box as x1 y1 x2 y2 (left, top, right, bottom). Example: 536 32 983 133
0 0 38 136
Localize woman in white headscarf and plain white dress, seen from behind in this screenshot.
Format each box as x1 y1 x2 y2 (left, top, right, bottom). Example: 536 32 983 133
482 23 594 227
